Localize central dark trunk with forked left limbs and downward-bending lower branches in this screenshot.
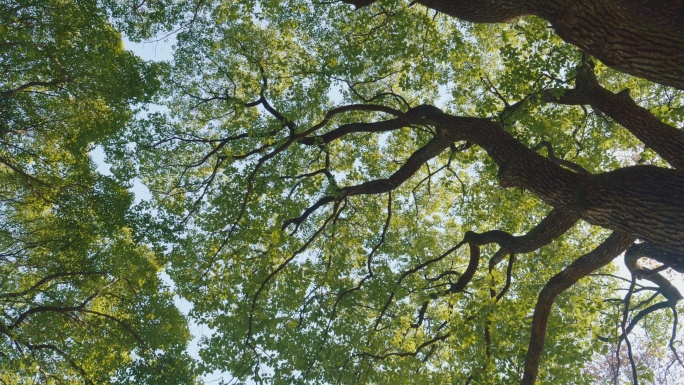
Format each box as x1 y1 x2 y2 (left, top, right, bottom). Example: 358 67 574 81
296 103 684 384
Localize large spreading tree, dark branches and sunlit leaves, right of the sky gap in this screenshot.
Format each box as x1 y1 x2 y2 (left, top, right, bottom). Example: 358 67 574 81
108 0 684 384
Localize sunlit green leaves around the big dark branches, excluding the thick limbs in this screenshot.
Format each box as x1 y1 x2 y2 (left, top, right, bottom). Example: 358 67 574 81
112 1 670 384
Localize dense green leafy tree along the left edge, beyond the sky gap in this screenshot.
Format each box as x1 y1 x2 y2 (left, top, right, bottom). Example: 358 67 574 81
0 0 195 384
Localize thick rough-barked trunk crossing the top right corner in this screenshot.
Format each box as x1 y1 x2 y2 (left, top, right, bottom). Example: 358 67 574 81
346 0 684 89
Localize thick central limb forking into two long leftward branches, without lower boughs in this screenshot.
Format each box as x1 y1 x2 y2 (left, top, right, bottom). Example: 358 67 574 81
302 105 684 255
